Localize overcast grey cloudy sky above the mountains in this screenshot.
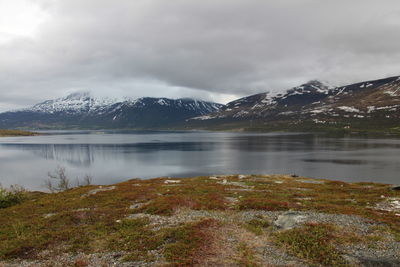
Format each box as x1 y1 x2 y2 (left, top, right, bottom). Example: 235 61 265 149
0 0 400 111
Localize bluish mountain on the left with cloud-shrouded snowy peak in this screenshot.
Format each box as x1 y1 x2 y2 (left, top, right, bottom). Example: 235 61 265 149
0 92 222 128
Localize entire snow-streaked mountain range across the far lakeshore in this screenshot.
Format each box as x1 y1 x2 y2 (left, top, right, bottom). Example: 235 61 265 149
0 76 400 132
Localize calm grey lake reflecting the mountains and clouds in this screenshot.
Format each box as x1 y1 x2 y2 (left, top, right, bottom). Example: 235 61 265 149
0 131 400 190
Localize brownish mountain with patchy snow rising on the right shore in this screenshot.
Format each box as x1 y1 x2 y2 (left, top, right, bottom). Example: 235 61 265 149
189 76 400 132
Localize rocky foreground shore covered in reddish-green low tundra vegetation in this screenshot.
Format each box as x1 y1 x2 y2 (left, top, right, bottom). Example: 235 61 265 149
0 175 400 266
